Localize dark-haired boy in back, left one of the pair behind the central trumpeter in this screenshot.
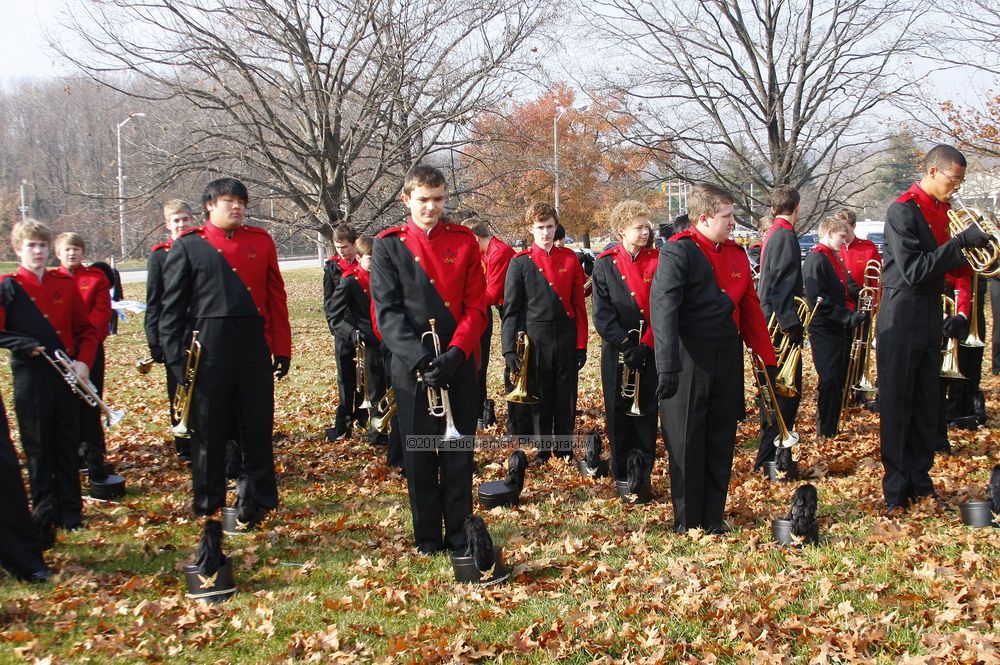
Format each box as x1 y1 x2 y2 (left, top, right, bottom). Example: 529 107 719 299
323 224 368 441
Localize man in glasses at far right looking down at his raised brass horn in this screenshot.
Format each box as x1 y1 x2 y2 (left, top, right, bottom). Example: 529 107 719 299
877 145 990 512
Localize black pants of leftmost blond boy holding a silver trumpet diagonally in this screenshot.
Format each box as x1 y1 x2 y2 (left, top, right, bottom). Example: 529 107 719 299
13 357 83 526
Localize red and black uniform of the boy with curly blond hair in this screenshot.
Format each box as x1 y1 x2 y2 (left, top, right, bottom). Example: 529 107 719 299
592 245 659 480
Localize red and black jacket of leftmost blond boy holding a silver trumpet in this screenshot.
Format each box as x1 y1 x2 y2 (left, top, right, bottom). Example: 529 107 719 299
0 267 100 368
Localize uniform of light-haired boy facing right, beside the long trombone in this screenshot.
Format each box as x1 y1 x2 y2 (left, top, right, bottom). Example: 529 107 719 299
802 243 861 437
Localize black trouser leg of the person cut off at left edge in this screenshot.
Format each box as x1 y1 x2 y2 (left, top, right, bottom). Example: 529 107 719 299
0 402 45 577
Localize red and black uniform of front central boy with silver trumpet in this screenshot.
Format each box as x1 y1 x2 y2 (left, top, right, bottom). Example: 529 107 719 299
371 220 486 552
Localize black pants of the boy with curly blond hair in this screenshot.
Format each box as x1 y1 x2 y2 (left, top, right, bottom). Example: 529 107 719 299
601 342 659 480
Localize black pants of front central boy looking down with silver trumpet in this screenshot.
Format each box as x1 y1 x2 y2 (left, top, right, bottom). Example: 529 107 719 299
392 358 479 552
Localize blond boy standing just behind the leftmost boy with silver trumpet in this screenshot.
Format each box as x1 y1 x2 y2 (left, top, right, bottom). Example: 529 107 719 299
56 233 114 472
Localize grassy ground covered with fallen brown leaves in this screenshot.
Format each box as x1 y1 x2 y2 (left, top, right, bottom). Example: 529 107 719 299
0 270 1000 663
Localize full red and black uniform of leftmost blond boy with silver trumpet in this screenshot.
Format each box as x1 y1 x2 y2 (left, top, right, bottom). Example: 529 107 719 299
0 267 98 528
